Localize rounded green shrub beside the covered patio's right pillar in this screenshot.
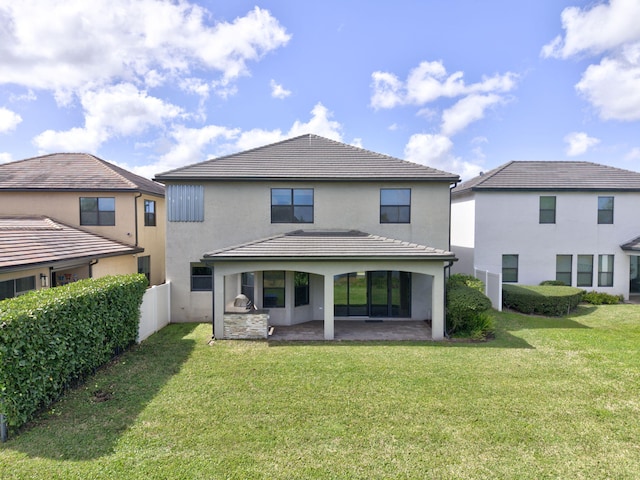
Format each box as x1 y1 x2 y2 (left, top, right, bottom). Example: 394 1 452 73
447 276 494 339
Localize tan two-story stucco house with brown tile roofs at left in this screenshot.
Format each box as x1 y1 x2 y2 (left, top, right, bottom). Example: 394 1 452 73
0 153 165 298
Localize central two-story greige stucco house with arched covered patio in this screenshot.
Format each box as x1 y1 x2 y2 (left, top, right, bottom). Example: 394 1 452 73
156 135 458 339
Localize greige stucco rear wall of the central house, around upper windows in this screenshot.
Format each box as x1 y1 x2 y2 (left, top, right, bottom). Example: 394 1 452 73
166 182 449 322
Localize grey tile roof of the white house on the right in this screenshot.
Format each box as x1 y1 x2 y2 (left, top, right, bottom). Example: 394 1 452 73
452 161 640 197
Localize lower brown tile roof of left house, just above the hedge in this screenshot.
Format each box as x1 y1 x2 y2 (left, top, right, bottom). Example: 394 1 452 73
0 215 144 271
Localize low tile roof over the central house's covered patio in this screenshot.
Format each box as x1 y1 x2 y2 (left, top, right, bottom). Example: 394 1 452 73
203 230 455 260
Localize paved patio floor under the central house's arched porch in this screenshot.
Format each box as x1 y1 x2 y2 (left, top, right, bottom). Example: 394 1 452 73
269 320 432 341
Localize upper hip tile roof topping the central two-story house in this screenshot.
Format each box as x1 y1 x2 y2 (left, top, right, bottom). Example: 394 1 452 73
155 134 459 182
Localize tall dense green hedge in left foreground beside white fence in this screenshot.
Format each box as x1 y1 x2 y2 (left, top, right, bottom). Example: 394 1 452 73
0 274 147 427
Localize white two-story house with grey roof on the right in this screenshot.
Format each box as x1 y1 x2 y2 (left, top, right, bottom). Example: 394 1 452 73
451 161 640 299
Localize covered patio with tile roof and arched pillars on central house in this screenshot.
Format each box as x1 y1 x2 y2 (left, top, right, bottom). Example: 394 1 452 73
202 231 455 340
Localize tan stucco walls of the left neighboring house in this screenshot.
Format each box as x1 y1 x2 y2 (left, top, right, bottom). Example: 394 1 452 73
0 191 166 285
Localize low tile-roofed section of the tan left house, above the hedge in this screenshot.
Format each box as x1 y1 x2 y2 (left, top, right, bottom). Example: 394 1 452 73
0 215 143 300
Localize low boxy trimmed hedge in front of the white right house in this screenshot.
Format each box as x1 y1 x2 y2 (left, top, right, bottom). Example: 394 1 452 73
502 285 583 317
